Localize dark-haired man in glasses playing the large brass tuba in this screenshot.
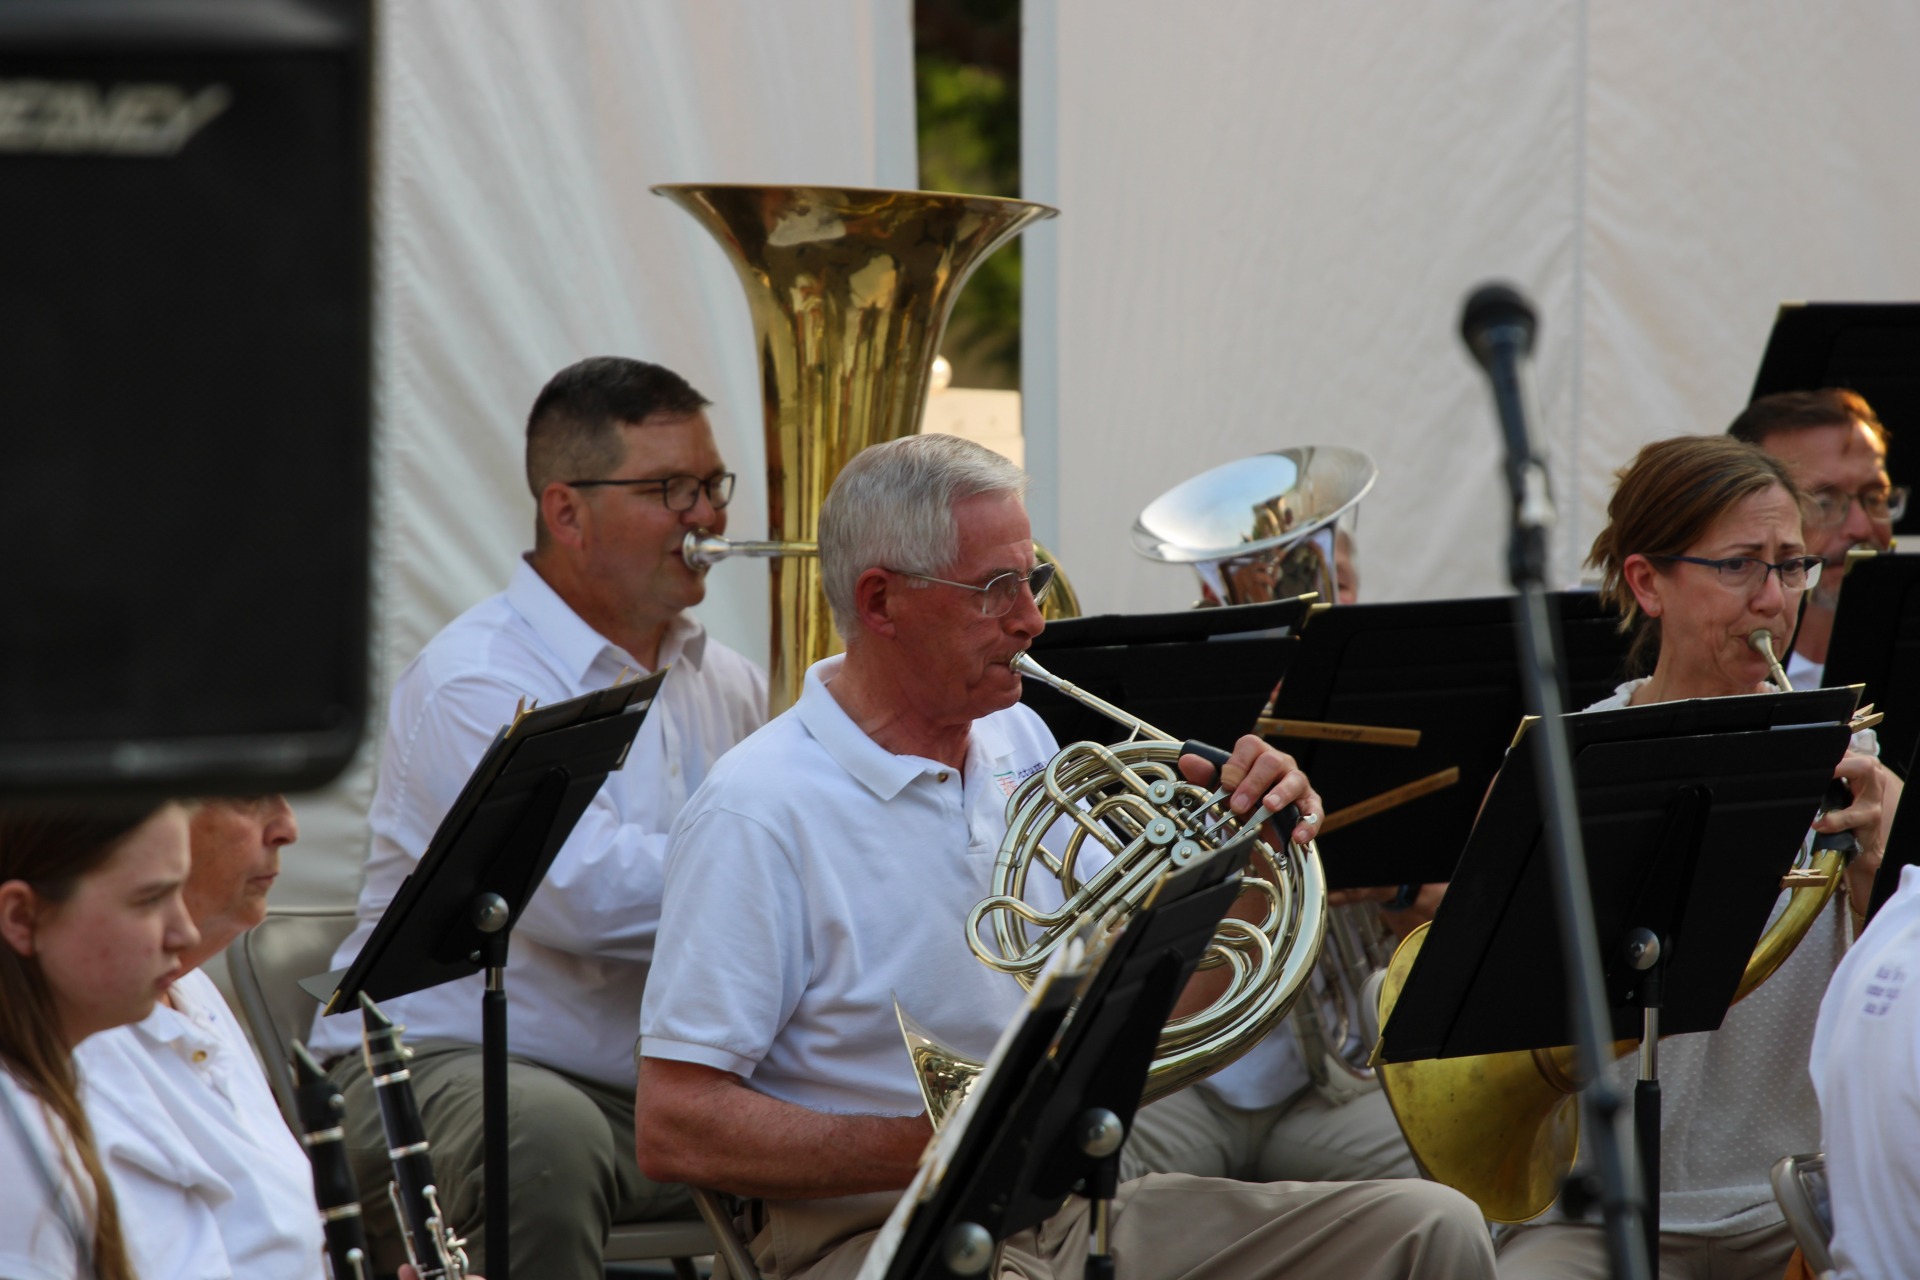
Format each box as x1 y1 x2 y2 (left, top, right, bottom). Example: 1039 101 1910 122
313 357 766 1280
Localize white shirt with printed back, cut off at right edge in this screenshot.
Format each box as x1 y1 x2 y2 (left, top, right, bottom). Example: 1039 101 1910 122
1812 867 1920 1280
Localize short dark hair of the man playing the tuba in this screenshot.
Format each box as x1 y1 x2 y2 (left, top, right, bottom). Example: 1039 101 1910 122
526 355 712 535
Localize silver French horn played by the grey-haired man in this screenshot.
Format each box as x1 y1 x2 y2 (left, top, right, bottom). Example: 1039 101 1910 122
900 654 1327 1125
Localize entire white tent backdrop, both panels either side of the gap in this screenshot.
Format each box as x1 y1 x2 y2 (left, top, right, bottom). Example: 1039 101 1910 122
280 0 1920 902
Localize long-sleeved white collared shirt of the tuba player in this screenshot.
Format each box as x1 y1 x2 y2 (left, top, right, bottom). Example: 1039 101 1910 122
313 560 766 1088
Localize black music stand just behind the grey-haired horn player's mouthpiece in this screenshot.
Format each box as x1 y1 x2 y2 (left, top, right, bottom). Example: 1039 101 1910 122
1021 595 1313 747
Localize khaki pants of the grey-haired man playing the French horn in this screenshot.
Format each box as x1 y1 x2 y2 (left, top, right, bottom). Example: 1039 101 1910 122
751 1174 1494 1280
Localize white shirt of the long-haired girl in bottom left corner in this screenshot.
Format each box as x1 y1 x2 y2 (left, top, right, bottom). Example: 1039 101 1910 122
0 1063 94 1280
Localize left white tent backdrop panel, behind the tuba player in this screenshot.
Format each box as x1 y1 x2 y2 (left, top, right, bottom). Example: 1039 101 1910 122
276 0 916 904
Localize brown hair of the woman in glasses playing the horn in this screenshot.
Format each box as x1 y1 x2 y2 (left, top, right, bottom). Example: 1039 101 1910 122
1586 436 1807 672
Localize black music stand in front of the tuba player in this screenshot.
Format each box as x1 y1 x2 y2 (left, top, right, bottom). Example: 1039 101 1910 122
301 670 666 1280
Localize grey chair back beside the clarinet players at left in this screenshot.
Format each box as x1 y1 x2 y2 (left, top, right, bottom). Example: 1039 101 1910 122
227 906 355 1134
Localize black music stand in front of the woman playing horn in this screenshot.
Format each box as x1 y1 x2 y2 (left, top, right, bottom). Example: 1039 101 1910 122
1379 689 1859 1257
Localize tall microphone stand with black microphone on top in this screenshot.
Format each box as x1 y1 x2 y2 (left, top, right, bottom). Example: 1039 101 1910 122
1461 284 1659 1280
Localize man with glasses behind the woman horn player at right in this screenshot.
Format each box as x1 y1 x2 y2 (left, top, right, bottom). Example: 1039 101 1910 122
1726 388 1907 689
